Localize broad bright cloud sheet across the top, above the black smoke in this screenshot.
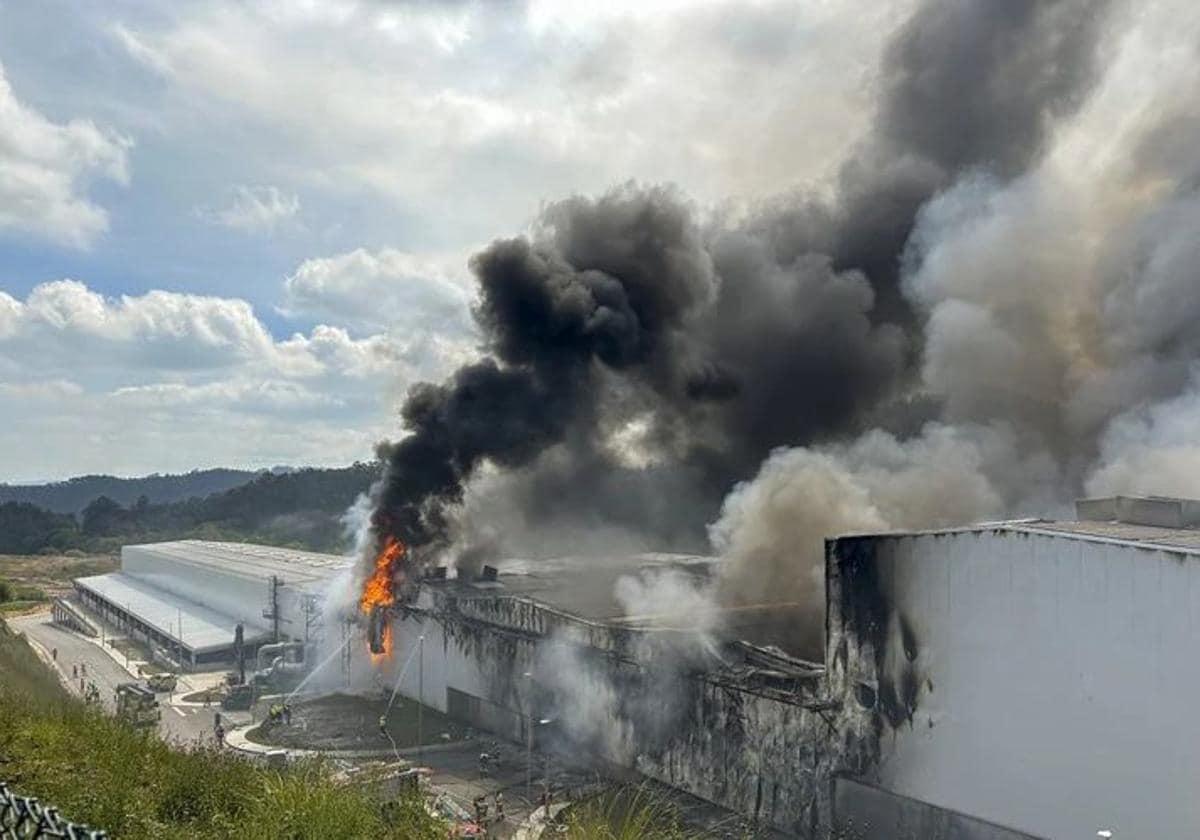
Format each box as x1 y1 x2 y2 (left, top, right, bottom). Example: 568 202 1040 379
114 0 911 237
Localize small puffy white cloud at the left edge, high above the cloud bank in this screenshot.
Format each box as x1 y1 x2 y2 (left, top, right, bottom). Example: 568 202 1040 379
0 60 132 247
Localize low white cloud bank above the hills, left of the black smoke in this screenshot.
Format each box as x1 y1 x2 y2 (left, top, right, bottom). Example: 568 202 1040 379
0 280 472 480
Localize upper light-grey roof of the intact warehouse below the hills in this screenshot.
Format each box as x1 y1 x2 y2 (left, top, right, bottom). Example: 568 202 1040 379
122 540 354 588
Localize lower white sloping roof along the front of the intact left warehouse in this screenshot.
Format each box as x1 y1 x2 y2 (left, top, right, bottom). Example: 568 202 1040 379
76 571 270 653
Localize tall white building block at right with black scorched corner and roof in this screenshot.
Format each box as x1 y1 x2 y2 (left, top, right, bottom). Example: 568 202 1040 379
826 497 1200 840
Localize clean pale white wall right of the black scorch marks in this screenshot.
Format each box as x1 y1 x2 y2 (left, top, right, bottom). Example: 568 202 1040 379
876 530 1200 840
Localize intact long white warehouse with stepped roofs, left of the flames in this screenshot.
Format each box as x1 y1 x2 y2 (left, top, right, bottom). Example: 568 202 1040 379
74 540 352 667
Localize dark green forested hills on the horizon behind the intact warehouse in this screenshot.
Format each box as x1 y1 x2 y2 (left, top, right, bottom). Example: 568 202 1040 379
0 462 380 554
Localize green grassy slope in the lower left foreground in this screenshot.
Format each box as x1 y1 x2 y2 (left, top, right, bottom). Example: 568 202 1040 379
0 622 446 840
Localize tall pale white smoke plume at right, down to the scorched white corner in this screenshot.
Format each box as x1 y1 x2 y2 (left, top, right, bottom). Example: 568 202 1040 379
710 0 1200 648
